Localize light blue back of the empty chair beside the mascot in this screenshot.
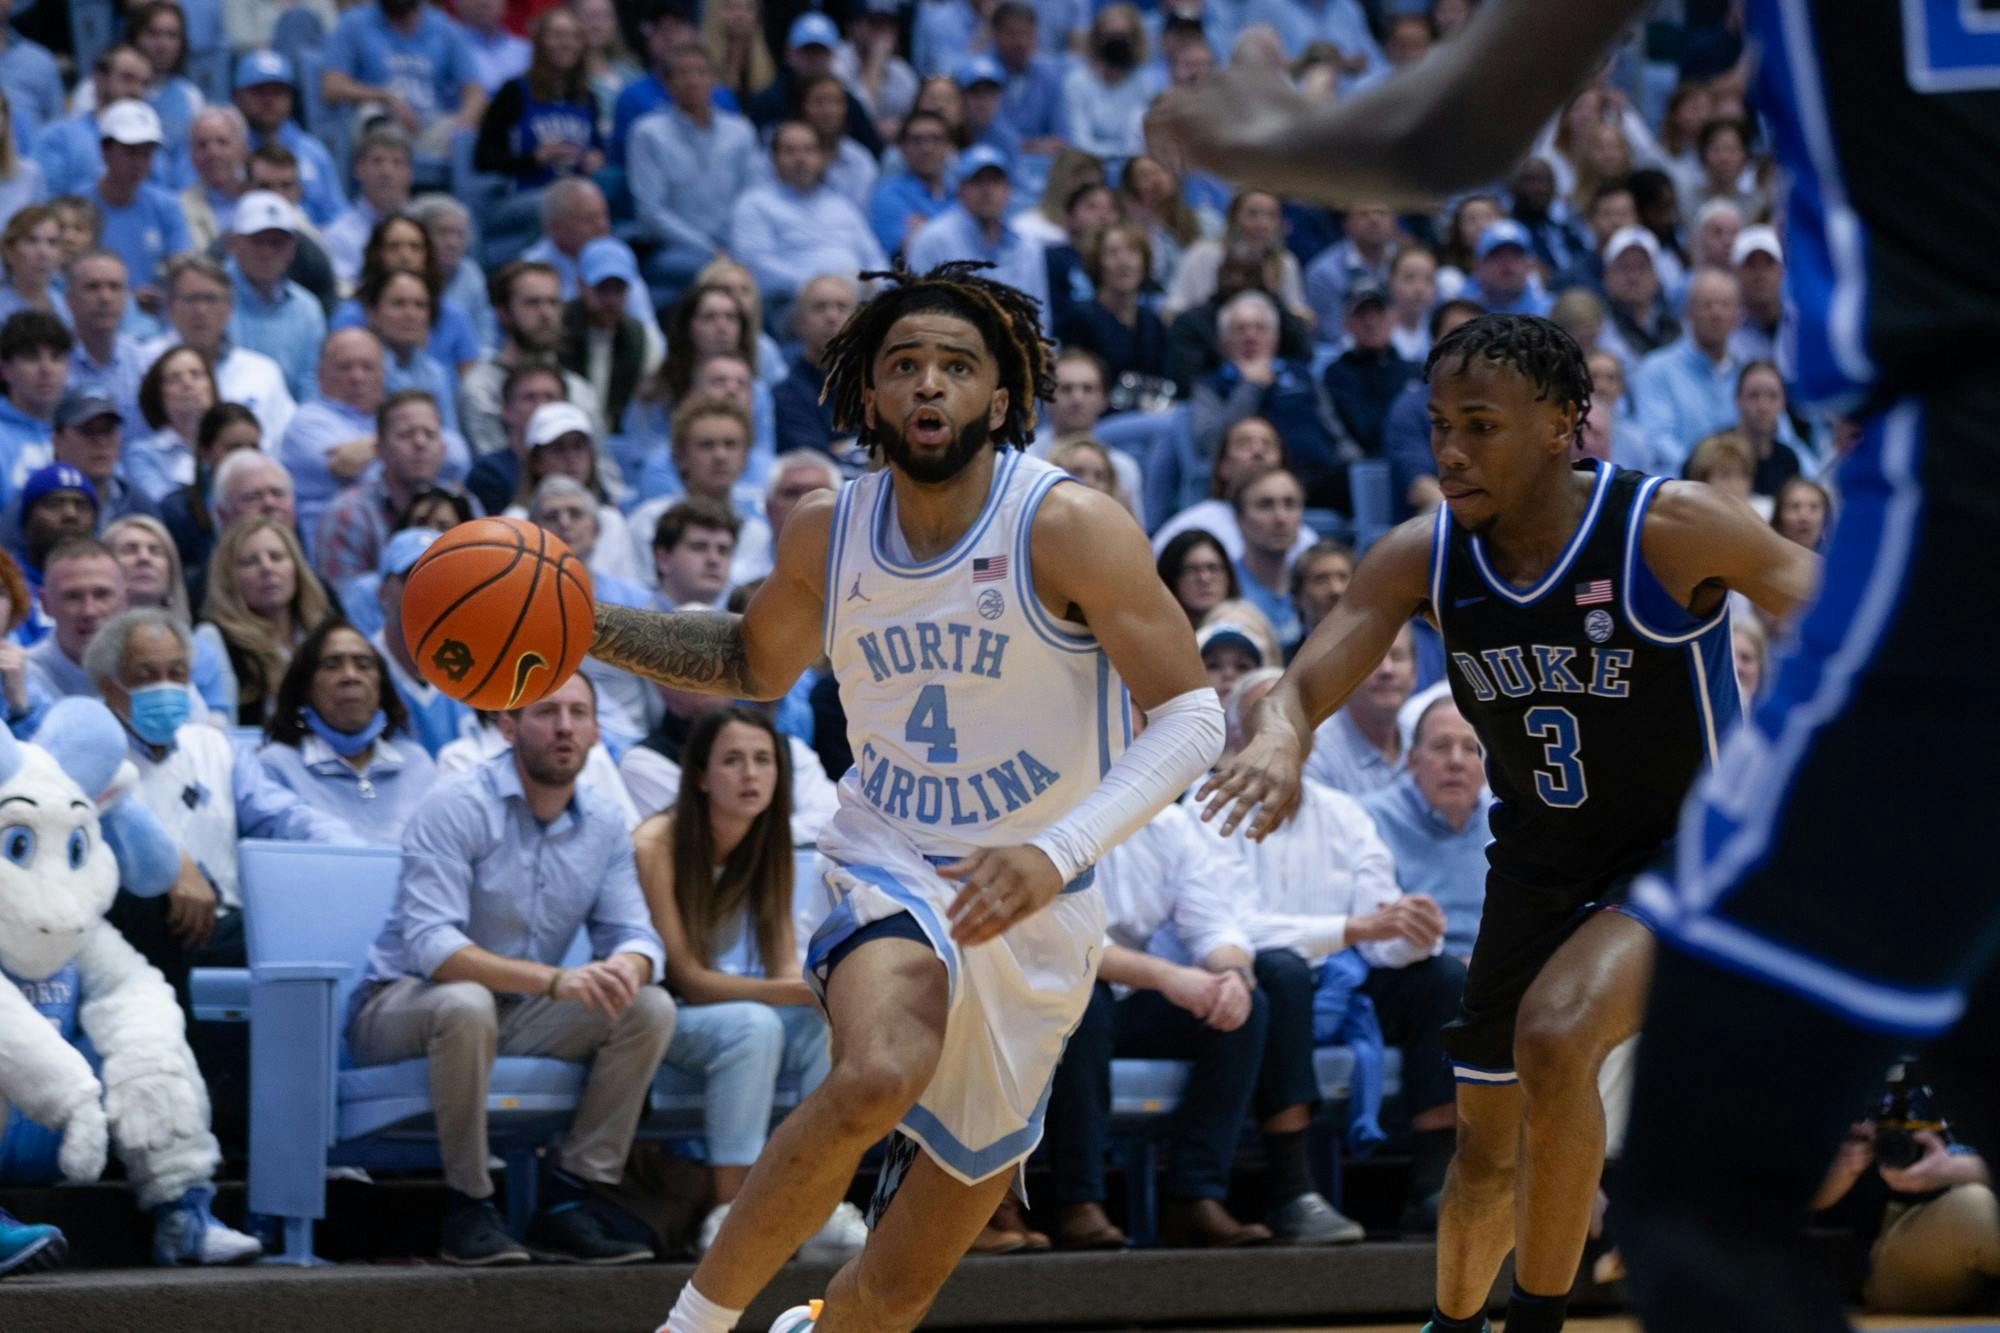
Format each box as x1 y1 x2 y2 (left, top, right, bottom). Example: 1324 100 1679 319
236 839 402 1023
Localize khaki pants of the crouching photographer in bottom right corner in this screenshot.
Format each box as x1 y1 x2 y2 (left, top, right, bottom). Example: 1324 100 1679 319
1862 1185 2000 1315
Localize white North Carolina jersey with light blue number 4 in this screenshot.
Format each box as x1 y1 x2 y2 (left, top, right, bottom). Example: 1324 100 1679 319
820 448 1132 859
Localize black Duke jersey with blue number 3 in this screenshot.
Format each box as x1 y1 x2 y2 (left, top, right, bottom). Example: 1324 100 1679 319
1430 462 1740 895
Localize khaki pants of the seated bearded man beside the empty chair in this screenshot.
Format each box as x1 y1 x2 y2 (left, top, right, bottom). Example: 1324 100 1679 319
348 977 674 1199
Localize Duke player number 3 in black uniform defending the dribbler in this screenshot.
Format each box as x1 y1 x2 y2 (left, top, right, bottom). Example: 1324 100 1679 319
1200 314 1818 1333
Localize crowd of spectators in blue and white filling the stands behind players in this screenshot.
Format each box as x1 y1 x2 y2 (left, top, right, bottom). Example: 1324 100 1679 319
0 0 1984 1304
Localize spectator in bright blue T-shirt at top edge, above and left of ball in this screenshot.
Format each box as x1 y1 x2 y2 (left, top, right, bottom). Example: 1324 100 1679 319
320 0 486 156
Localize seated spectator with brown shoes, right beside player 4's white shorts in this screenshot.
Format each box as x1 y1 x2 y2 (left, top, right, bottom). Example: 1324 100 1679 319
1048 784 1270 1249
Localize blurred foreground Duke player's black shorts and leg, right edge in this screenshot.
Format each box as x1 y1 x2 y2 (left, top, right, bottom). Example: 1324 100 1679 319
1620 374 2000 1331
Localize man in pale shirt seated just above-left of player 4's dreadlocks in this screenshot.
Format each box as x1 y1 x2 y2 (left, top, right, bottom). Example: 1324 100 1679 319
730 120 884 300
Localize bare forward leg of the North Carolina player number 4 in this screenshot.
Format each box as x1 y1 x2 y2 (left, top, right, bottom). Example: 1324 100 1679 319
666 917 948 1333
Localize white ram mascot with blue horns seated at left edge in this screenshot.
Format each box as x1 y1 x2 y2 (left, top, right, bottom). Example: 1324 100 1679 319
0 699 260 1273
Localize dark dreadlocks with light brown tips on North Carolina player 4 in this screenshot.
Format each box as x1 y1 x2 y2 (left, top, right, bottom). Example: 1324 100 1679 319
820 260 1056 448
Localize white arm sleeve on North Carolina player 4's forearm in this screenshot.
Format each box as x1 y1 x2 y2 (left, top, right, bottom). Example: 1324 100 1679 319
1028 685 1222 883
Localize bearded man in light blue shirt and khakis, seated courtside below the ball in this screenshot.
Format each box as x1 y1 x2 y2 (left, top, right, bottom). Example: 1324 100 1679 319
348 677 674 1265
